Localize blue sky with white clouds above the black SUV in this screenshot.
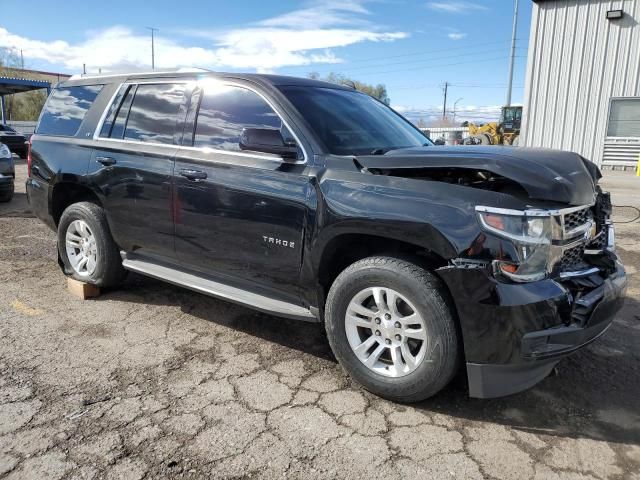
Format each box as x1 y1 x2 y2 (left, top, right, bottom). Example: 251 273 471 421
0 0 531 124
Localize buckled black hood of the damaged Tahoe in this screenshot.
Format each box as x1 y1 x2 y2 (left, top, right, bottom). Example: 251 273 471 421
357 146 600 206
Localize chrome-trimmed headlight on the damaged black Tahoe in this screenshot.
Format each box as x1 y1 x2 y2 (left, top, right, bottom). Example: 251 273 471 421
476 207 551 282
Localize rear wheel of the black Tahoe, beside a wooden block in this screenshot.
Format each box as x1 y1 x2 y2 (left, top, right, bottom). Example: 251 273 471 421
58 202 127 287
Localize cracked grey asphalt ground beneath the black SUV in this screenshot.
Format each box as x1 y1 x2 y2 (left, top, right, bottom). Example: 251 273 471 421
0 164 640 480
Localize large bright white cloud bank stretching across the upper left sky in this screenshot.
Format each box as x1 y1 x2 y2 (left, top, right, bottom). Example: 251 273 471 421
0 0 408 72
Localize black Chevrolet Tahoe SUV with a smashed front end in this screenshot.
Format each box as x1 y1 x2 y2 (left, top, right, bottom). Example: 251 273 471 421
27 72 626 402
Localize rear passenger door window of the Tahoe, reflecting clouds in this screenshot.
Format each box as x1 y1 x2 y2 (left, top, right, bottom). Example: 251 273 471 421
124 83 184 144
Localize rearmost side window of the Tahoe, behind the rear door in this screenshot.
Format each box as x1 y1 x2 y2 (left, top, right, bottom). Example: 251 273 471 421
36 85 103 137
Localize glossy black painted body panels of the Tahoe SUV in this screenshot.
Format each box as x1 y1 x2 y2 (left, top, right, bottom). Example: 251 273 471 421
27 74 624 397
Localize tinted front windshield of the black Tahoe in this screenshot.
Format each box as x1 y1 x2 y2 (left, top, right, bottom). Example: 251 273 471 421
280 86 431 155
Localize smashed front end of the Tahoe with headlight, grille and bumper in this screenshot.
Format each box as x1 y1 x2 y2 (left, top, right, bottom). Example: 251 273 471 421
438 189 627 398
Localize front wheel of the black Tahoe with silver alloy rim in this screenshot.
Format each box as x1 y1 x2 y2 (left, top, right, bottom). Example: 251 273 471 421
325 256 461 403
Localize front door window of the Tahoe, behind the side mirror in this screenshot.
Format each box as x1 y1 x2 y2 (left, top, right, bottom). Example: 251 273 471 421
193 85 287 150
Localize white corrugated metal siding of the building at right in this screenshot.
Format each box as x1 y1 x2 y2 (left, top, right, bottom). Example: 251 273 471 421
521 0 640 164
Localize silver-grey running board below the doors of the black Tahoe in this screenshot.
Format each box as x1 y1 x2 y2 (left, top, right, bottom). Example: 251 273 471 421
122 255 317 321
